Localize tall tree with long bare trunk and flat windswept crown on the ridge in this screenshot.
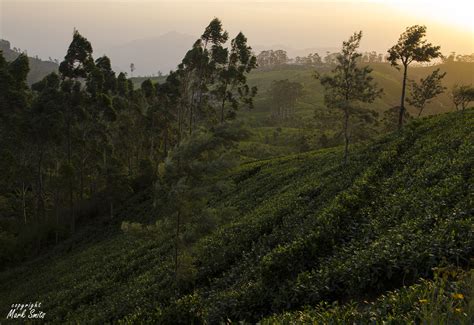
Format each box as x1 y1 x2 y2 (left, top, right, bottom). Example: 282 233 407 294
388 25 441 128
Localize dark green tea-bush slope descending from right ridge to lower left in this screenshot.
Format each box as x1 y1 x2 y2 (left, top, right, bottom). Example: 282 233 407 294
0 109 474 324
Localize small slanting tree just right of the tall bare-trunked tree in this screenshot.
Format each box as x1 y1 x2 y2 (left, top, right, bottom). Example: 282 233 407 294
407 69 446 117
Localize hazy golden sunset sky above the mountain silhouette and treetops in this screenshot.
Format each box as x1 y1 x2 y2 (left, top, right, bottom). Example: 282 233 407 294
0 0 474 64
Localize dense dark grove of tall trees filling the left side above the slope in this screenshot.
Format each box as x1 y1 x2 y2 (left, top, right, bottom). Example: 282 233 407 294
0 18 256 267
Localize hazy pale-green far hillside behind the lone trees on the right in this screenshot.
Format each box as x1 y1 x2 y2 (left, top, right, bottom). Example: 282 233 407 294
133 62 474 160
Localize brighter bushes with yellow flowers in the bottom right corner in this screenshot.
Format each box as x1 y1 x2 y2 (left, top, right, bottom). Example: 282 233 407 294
261 268 474 324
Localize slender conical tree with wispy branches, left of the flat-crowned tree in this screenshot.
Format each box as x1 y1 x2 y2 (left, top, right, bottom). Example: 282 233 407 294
315 32 382 164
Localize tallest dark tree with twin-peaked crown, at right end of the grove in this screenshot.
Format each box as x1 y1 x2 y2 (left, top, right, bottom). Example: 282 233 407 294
174 18 257 135
